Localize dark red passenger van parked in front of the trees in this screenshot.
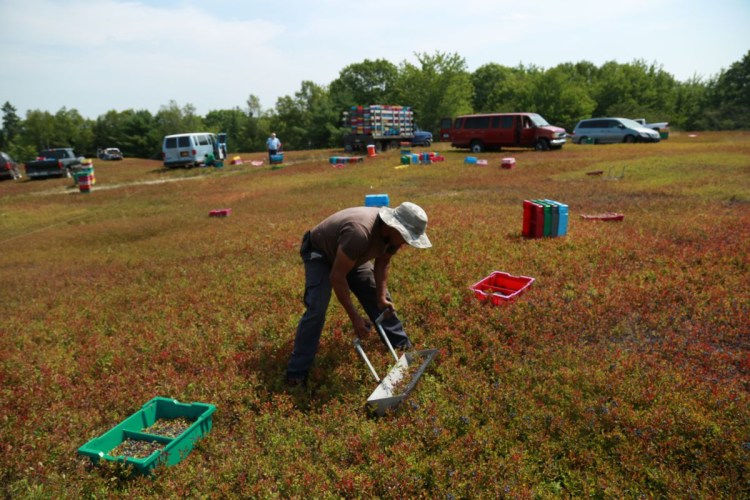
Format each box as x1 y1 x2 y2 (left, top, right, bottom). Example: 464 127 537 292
440 113 567 153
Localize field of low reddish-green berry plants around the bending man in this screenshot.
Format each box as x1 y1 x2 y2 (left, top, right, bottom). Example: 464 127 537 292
0 133 750 498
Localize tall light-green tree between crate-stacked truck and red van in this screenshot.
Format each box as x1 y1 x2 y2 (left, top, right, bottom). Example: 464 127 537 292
396 52 473 133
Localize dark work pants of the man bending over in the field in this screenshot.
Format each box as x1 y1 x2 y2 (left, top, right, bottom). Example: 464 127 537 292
287 234 409 378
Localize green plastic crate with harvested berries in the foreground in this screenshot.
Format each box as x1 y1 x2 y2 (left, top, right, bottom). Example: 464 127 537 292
78 397 216 474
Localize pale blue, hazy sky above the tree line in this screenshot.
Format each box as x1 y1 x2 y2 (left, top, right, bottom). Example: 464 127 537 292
0 0 750 118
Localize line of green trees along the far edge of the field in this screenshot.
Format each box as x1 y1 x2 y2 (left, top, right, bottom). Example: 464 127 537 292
0 51 750 161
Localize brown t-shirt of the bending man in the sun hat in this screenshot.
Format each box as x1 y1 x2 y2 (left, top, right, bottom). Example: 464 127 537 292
310 207 386 266
